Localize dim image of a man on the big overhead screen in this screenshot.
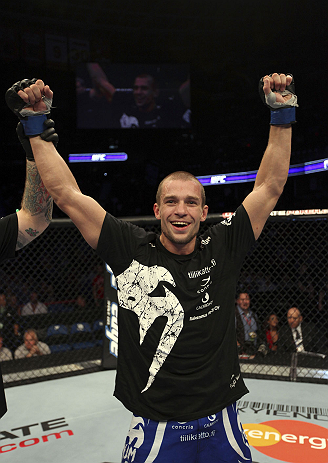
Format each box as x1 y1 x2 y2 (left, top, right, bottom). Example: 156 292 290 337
77 63 190 128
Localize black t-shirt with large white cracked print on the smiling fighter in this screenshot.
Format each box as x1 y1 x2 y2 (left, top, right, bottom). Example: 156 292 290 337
97 206 254 421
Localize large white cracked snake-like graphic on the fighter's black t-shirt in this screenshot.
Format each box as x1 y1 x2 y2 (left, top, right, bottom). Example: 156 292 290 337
116 260 184 392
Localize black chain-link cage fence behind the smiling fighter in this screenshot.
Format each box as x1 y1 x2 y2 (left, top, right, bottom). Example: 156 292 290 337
0 211 328 387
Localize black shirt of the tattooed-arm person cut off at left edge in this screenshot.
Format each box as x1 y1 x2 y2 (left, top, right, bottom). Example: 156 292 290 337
0 214 18 418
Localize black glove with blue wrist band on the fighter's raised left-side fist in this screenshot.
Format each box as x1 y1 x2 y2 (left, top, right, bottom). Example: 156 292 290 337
5 78 52 136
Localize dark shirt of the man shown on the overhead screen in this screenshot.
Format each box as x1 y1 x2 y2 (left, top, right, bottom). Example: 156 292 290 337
110 91 190 129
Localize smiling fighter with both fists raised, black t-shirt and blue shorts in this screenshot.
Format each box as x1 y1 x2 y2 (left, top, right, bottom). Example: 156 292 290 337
8 73 297 463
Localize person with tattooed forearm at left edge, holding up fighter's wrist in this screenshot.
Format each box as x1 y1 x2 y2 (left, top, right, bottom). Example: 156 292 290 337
0 115 53 418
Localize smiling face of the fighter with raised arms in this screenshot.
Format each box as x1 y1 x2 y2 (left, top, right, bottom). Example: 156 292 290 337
154 180 208 254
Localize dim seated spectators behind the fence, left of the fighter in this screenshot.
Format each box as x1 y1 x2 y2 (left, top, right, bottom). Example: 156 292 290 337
0 265 104 361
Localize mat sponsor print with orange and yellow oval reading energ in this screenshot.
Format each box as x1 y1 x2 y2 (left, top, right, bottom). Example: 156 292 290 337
237 399 328 463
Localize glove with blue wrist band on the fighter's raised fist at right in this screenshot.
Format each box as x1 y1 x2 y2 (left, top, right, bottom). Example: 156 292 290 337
259 74 298 125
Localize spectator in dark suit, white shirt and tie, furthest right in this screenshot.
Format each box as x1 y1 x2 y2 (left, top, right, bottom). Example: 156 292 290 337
279 307 317 352
